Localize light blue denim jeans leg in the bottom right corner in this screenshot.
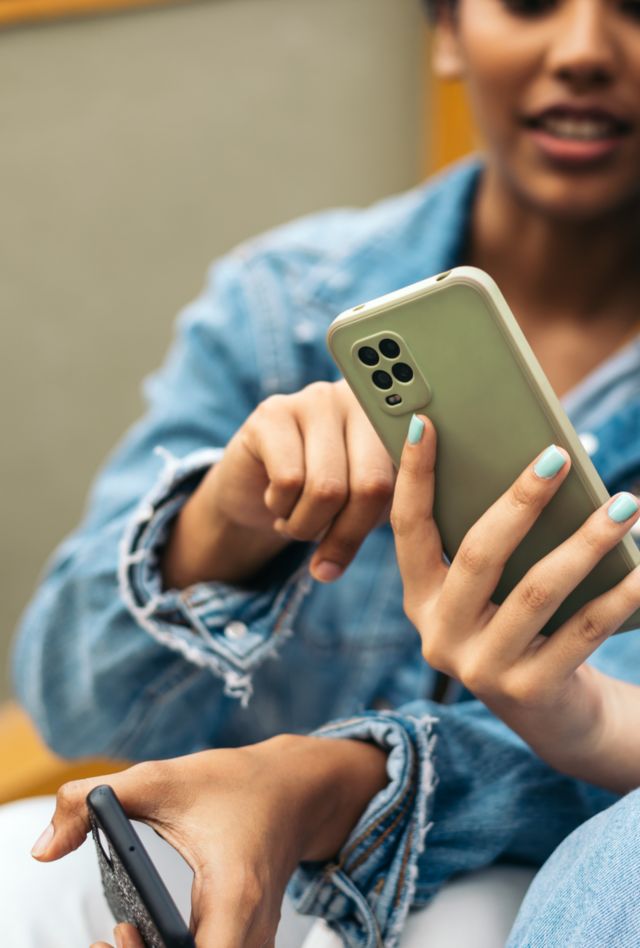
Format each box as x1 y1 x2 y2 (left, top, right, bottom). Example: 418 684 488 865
507 790 640 948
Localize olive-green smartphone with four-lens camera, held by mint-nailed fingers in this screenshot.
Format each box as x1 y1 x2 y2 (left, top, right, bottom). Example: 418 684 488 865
327 267 640 635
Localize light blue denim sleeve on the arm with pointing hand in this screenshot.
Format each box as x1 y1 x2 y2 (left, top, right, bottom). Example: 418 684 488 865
13 252 311 759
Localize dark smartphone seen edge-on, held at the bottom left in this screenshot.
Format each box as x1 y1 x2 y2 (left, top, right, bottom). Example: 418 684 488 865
87 785 195 948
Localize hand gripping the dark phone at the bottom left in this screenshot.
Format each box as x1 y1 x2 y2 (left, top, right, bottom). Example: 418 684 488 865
32 734 387 948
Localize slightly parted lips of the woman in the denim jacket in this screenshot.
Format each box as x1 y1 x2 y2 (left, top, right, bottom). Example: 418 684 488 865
523 102 633 168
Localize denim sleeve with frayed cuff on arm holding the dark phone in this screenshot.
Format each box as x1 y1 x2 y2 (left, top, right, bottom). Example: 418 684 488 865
289 701 616 948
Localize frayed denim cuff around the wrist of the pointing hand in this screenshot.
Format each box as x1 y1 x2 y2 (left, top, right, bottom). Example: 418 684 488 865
119 448 313 706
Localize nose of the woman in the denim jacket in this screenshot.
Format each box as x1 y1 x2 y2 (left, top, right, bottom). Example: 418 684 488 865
548 0 619 91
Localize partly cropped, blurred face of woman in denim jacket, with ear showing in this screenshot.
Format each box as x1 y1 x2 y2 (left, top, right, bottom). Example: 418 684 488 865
435 0 640 220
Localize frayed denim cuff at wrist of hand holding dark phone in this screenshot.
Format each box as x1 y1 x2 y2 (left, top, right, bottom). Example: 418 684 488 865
289 711 437 948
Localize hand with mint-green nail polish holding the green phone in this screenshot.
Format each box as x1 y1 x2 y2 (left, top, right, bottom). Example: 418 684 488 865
391 415 640 791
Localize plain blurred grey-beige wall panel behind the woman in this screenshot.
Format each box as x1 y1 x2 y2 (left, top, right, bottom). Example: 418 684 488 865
0 0 423 695
